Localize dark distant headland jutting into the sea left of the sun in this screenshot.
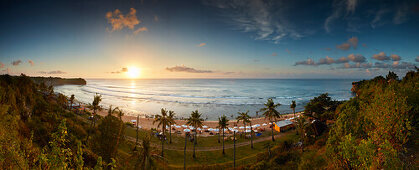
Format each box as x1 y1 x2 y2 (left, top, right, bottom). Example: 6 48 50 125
31 77 86 86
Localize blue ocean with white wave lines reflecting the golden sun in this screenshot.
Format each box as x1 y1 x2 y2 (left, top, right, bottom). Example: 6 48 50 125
54 79 358 120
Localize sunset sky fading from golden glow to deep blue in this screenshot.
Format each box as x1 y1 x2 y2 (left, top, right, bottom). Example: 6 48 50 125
0 0 419 79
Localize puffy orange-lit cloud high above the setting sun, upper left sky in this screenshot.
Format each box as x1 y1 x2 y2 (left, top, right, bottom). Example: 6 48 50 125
106 8 141 31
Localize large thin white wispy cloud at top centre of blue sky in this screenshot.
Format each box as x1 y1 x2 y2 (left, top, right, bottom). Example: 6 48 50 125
203 0 303 43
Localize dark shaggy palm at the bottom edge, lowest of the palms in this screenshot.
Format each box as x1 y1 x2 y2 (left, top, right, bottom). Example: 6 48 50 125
135 135 163 170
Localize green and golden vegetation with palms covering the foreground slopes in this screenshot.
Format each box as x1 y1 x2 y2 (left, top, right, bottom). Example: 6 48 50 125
0 70 419 169
